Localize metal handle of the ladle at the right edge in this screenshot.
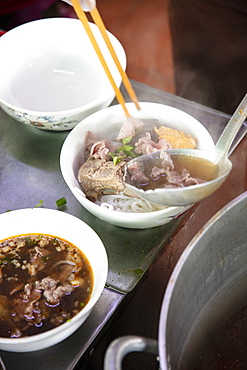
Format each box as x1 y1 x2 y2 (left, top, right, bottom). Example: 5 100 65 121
215 94 247 156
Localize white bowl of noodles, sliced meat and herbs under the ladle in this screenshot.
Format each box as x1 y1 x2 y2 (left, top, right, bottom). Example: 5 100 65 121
60 102 214 229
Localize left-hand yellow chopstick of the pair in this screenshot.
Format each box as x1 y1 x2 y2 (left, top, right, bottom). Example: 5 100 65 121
71 0 140 117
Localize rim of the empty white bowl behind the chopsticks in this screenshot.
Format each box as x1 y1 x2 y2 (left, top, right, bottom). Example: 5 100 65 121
0 17 127 117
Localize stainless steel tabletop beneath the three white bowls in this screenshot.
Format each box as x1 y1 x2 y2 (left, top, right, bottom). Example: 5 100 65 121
0 82 239 370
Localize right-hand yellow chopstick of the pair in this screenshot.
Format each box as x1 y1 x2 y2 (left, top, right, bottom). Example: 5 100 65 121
90 7 141 110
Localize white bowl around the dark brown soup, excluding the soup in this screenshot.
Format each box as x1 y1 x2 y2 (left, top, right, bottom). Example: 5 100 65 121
0 208 108 352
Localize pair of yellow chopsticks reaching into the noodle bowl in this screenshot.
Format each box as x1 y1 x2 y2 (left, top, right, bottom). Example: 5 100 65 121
71 0 141 117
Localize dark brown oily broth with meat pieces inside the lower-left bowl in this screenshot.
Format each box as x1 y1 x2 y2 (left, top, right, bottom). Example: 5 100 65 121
0 234 94 338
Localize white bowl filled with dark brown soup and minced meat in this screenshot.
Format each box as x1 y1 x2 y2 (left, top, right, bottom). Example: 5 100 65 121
0 208 108 352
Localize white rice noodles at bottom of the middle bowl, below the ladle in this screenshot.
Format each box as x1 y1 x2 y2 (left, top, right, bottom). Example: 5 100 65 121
96 193 167 213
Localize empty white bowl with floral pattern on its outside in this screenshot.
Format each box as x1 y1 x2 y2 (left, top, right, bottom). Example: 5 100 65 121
0 18 126 131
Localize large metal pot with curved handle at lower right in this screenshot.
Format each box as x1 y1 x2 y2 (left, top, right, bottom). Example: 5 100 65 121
105 192 247 370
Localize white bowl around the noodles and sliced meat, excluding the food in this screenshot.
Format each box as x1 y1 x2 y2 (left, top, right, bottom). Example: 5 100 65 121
60 102 214 229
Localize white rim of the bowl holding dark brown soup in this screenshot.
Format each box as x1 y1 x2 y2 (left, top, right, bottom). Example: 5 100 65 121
0 208 108 348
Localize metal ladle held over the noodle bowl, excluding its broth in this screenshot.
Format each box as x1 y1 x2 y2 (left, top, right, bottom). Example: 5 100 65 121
125 94 247 206
